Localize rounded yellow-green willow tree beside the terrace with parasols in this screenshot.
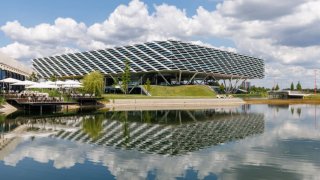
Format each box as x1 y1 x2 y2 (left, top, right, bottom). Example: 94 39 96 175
83 71 104 96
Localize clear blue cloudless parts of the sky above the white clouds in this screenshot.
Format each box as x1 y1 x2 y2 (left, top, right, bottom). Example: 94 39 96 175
0 0 229 46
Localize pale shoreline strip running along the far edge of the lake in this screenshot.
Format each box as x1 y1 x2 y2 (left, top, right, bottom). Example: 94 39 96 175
0 98 320 115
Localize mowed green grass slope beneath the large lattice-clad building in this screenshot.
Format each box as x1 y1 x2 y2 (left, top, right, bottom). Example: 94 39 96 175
150 85 216 97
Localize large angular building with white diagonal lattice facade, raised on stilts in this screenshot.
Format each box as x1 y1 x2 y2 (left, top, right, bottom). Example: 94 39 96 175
33 40 264 89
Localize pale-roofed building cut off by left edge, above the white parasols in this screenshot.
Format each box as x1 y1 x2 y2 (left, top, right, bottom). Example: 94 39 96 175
0 53 32 80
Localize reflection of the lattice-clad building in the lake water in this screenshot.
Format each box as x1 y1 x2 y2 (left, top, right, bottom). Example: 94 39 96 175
2 110 264 155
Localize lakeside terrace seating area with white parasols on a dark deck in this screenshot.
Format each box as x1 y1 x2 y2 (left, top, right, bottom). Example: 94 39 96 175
0 78 102 107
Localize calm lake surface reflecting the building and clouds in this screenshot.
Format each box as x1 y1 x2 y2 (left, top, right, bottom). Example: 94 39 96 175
0 105 320 180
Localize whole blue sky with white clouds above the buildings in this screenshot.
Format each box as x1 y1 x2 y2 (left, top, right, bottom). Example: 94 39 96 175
0 0 320 88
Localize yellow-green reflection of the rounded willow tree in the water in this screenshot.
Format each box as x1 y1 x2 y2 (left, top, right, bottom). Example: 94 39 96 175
82 114 104 139
